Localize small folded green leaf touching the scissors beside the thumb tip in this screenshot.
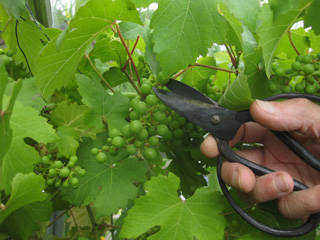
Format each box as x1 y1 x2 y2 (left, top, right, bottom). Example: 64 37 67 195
219 72 253 111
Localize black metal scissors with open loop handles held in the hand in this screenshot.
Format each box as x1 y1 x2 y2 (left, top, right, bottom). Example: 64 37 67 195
153 79 320 237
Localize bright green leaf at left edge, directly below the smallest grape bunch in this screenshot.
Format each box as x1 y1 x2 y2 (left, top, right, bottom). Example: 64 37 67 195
0 173 47 224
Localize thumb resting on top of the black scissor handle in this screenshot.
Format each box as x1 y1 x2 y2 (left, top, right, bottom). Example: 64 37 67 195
250 98 320 139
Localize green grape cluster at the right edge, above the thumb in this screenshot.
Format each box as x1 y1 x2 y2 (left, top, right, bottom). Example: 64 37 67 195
268 53 320 94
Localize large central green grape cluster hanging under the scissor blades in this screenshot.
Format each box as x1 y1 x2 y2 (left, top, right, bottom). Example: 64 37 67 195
91 78 204 163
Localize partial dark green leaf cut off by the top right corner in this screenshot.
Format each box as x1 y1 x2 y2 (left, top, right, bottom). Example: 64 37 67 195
304 0 320 35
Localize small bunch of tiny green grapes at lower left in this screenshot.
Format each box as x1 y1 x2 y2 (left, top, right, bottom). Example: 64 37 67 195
37 154 86 188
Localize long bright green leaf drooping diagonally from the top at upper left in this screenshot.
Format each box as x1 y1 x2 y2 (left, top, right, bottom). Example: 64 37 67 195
35 0 141 98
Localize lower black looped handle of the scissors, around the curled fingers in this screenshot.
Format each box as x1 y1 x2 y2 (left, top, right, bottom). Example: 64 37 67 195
216 139 320 237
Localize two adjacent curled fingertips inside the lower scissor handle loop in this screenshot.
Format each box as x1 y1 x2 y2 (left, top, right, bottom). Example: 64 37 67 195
221 162 294 203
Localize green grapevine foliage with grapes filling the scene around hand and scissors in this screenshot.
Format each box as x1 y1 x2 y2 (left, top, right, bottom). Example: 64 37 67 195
0 0 320 240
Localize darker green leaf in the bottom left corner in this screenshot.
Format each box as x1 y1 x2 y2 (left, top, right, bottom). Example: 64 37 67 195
0 199 52 240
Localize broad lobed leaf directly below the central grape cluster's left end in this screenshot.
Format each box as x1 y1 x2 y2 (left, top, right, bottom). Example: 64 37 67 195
62 134 146 216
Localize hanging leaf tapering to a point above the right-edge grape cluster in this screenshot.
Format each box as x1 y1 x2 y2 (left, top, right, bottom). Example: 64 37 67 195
257 0 311 77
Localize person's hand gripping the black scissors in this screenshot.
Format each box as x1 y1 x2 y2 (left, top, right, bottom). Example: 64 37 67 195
201 99 320 218
